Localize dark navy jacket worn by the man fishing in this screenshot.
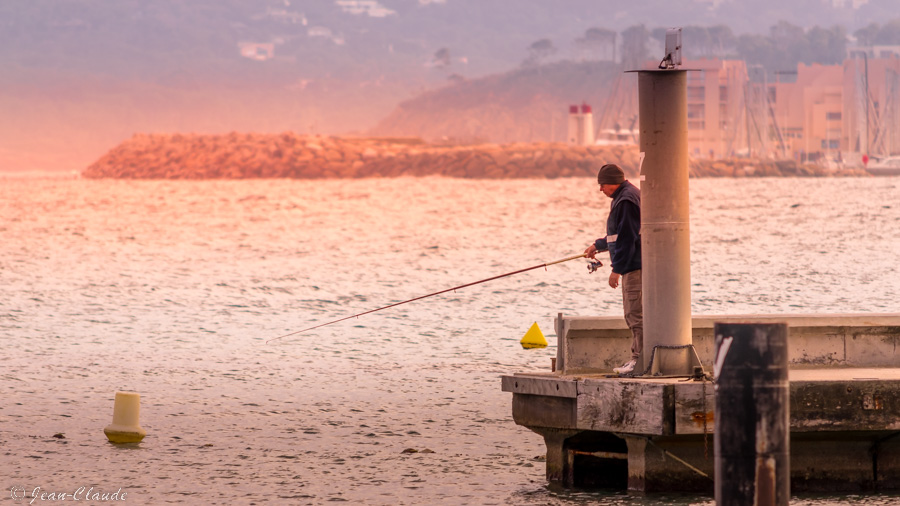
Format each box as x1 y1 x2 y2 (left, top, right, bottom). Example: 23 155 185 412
594 181 641 274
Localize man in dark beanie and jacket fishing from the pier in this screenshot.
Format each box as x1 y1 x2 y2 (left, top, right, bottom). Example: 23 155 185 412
584 163 644 374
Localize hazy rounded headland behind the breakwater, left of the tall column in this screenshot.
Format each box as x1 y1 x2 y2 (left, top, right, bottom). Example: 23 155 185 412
370 62 633 143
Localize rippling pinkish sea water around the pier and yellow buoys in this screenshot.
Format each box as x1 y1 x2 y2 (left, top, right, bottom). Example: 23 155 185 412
0 177 900 506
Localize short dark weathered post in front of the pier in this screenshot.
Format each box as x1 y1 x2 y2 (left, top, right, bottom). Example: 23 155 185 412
714 323 791 506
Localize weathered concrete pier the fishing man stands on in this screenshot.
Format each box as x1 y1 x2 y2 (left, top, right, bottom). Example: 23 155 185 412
501 314 900 493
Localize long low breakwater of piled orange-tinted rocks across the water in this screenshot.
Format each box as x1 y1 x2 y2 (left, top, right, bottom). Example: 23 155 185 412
82 133 864 179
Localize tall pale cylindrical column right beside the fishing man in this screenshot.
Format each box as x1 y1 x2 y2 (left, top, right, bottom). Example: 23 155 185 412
638 69 692 374
